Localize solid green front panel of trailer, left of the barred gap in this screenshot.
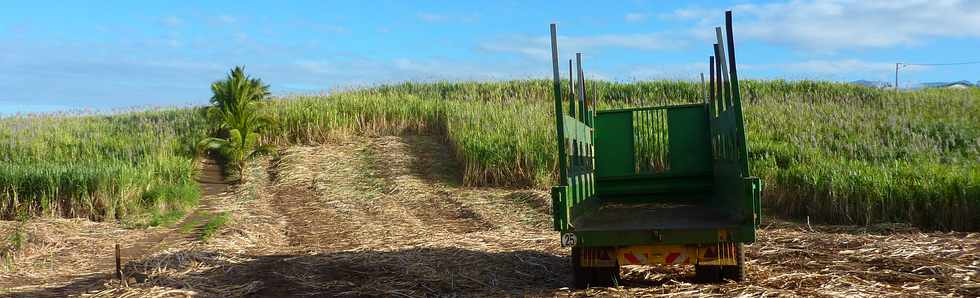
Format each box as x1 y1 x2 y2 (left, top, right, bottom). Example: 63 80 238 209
595 111 634 178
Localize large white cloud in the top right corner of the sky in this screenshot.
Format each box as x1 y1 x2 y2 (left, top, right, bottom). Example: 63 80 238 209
666 0 980 51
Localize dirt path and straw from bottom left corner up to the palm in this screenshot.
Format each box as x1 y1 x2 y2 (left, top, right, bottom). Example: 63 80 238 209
0 160 228 297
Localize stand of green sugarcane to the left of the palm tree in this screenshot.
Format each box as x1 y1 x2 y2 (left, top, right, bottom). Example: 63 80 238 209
0 109 206 225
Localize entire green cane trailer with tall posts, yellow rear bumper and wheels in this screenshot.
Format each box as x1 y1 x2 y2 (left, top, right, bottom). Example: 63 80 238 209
551 11 762 288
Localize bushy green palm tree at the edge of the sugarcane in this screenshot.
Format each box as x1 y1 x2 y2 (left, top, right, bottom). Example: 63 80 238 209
197 66 275 181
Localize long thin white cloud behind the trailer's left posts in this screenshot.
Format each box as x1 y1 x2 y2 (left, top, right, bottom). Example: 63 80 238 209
479 33 687 60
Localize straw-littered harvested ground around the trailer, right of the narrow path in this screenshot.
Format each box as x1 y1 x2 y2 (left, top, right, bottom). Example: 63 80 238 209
0 136 980 297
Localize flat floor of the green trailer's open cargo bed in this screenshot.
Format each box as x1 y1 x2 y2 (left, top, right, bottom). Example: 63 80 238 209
573 202 741 232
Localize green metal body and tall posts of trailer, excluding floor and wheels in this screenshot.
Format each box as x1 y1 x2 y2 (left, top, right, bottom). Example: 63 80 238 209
551 12 763 247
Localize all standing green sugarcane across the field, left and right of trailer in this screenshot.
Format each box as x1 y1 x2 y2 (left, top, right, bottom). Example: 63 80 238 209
0 80 980 230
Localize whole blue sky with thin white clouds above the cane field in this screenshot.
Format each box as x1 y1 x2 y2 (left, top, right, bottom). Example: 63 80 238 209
0 0 980 113
